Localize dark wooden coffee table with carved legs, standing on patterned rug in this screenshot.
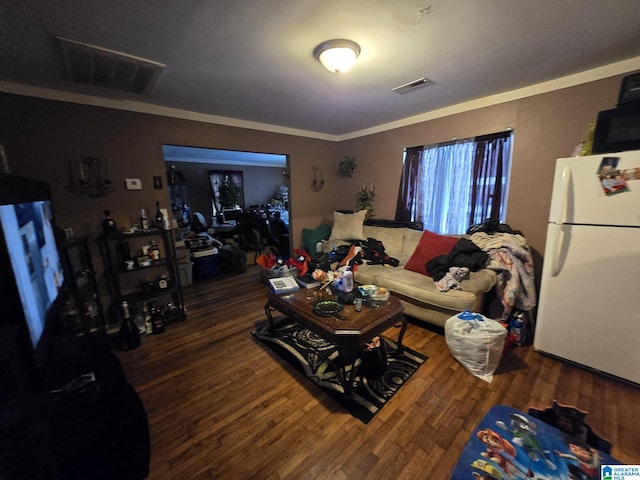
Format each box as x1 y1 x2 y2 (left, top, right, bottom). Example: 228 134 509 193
264 288 407 395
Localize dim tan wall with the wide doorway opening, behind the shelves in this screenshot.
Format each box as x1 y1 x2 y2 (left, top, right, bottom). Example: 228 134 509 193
0 95 337 251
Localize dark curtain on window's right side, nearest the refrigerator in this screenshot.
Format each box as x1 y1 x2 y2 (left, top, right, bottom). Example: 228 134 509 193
469 132 511 225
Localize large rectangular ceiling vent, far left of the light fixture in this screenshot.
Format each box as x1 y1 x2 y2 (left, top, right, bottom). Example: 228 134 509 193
57 37 166 95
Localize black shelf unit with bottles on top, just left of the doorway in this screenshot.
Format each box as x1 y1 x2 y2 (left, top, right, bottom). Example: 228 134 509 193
102 229 186 330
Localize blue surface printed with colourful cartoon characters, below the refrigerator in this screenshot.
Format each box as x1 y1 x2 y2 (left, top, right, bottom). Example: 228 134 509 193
451 405 621 480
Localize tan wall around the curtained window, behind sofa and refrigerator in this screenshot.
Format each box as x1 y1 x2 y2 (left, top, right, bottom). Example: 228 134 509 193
338 76 623 260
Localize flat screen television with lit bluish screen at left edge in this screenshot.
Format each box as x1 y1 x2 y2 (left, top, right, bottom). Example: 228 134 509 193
0 174 65 367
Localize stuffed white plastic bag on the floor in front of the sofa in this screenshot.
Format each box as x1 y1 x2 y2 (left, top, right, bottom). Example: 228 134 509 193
444 310 507 383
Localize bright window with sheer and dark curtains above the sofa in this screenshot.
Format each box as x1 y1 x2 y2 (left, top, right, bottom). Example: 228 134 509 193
396 132 513 235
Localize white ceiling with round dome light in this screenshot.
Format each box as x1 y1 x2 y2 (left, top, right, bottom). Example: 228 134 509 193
0 0 640 137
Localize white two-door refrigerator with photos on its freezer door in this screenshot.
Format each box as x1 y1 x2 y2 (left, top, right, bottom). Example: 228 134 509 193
533 150 640 384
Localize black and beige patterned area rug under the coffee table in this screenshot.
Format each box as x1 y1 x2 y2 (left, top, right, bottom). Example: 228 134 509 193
251 318 427 423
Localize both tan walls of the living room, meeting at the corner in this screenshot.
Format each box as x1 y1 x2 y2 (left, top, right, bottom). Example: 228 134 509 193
0 71 623 276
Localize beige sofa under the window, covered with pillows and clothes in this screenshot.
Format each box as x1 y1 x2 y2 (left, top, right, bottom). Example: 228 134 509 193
322 220 496 327
